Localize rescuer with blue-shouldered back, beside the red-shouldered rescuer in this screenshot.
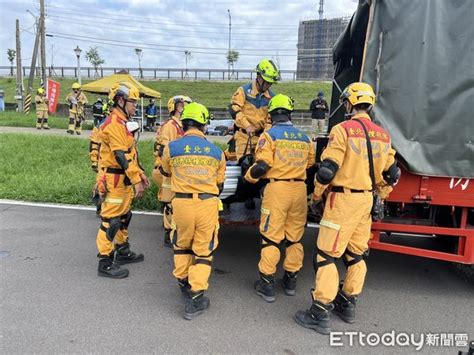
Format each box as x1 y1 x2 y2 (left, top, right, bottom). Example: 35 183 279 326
245 94 315 302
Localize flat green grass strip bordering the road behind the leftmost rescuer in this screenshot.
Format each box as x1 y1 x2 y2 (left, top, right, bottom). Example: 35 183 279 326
0 134 158 211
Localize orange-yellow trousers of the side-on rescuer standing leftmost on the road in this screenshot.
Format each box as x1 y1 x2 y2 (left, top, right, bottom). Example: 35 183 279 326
96 173 133 256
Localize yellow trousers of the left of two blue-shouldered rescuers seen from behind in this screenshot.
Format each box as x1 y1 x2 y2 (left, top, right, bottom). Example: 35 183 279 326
171 196 219 292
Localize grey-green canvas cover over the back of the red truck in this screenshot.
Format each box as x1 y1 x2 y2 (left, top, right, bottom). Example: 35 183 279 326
330 0 474 178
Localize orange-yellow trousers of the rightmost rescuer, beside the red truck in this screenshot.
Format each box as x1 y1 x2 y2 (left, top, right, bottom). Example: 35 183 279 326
313 191 372 304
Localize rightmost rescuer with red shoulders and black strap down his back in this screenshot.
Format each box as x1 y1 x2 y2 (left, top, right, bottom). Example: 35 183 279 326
295 82 400 334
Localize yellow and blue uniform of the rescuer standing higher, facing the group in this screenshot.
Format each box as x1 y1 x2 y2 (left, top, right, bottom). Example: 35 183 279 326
231 80 274 160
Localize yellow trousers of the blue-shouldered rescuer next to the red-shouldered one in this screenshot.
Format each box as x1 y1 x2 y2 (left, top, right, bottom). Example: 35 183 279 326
258 181 308 275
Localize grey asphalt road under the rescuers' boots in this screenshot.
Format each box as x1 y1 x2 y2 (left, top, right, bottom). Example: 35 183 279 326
0 204 474 354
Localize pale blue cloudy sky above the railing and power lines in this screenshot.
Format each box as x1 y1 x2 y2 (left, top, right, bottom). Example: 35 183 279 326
0 0 357 69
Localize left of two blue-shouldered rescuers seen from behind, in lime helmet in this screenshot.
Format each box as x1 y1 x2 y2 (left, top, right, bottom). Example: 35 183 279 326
162 102 226 320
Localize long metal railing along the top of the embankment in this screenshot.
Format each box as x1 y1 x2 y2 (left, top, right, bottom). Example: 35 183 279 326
0 66 331 81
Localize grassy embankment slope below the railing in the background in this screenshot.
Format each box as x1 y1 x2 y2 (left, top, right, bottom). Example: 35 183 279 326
0 78 331 110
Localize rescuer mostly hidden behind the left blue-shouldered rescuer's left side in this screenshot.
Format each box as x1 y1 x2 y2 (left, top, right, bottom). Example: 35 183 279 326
153 95 191 248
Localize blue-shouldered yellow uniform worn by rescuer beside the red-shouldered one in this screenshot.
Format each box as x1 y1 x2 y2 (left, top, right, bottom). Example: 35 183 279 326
245 122 315 276
